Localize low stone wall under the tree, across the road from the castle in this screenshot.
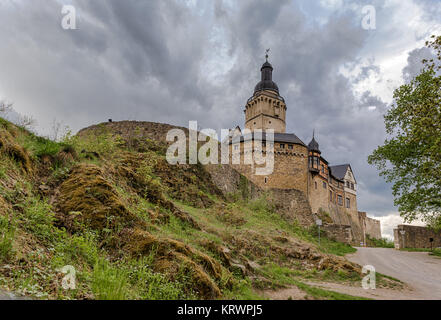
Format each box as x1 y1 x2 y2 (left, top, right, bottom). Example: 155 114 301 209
394 225 441 249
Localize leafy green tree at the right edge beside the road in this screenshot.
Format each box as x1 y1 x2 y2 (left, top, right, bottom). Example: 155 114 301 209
368 36 441 229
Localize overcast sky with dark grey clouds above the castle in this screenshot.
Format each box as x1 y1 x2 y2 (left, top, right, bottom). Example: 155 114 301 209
0 0 441 236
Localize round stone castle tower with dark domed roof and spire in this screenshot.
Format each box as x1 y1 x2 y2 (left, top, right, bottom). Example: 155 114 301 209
244 55 286 133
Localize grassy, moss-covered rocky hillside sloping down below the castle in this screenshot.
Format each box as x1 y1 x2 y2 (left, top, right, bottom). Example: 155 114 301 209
0 119 398 299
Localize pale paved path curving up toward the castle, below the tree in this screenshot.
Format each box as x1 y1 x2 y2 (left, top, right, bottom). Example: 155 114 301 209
346 248 441 300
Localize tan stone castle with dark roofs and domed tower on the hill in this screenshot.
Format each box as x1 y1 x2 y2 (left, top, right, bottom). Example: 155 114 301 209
230 56 381 243
